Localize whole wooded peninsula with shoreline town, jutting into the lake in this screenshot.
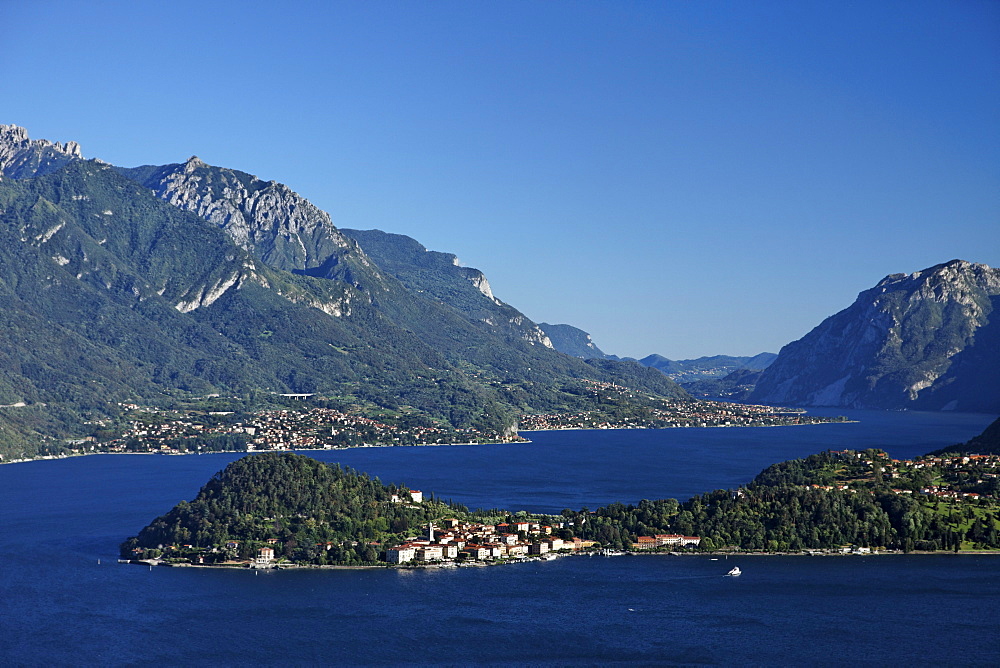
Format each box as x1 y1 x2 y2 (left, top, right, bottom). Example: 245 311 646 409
121 418 1000 568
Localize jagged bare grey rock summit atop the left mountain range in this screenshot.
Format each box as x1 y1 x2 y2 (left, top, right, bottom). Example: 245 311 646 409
119 156 386 292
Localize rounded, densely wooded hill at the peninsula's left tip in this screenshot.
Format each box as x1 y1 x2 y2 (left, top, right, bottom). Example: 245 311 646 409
121 453 461 563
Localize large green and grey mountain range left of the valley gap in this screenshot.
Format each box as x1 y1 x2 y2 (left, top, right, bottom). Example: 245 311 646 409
0 126 687 454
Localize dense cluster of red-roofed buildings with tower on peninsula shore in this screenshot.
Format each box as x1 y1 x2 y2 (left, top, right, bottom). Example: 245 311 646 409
385 519 595 564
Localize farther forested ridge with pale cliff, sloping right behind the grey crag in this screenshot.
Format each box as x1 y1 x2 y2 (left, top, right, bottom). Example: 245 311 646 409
341 229 553 348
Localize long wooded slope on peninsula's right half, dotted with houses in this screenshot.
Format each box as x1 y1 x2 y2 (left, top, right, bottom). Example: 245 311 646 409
564 450 1000 551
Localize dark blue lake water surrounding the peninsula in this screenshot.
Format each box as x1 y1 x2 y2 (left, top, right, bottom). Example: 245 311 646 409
0 411 1000 665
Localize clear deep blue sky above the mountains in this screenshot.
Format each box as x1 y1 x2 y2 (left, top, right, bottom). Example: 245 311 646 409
0 0 1000 359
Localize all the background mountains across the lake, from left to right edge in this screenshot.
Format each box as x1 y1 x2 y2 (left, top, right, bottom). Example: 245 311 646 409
0 125 1000 456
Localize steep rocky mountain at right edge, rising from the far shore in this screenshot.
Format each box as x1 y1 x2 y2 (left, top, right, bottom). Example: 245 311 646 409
750 260 1000 412
